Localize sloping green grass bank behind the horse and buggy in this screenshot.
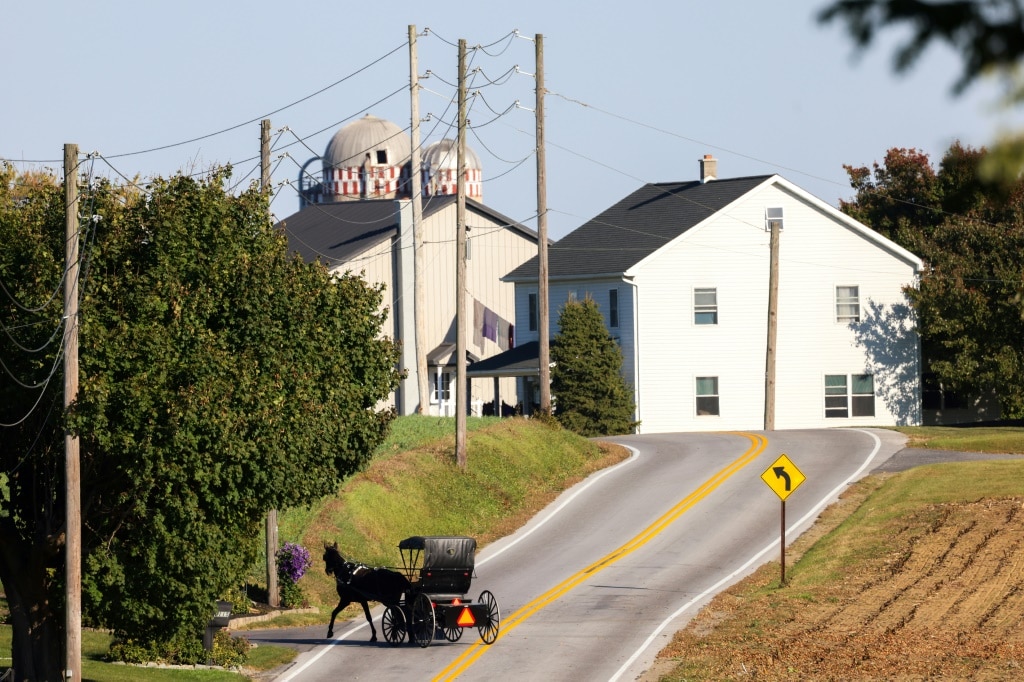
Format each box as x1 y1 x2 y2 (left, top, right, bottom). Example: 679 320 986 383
292 418 624 606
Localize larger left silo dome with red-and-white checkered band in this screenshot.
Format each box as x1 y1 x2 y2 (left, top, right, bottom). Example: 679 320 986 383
323 114 412 202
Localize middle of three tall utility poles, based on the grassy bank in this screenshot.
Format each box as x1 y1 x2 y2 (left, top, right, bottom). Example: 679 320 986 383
455 38 469 469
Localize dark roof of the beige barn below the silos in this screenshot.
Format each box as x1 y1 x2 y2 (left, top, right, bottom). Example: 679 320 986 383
276 196 538 266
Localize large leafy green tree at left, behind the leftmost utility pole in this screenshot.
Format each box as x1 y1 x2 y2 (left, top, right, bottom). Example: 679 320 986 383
0 160 398 679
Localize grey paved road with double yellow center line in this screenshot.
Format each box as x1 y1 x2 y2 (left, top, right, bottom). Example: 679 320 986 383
247 429 1015 681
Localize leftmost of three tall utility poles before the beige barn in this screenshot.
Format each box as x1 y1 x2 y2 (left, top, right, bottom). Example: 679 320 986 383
409 25 430 415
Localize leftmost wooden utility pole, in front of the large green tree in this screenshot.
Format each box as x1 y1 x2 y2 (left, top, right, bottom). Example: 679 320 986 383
63 144 82 682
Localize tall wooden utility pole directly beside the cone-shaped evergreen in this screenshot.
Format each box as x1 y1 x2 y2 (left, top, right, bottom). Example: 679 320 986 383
534 34 551 415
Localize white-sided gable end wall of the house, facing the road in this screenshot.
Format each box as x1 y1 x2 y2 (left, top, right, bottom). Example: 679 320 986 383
636 176 920 433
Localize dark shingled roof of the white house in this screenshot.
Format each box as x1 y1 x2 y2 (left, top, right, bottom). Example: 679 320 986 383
503 175 774 282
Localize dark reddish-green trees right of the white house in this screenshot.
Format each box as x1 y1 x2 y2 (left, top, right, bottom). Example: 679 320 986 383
840 142 1024 419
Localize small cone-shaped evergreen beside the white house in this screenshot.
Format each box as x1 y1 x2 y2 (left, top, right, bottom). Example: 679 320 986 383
551 298 637 436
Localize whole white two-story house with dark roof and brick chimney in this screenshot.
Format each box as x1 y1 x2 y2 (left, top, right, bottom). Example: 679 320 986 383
499 157 922 433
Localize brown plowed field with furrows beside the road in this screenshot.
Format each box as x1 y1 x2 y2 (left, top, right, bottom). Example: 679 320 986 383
655 481 1024 680
